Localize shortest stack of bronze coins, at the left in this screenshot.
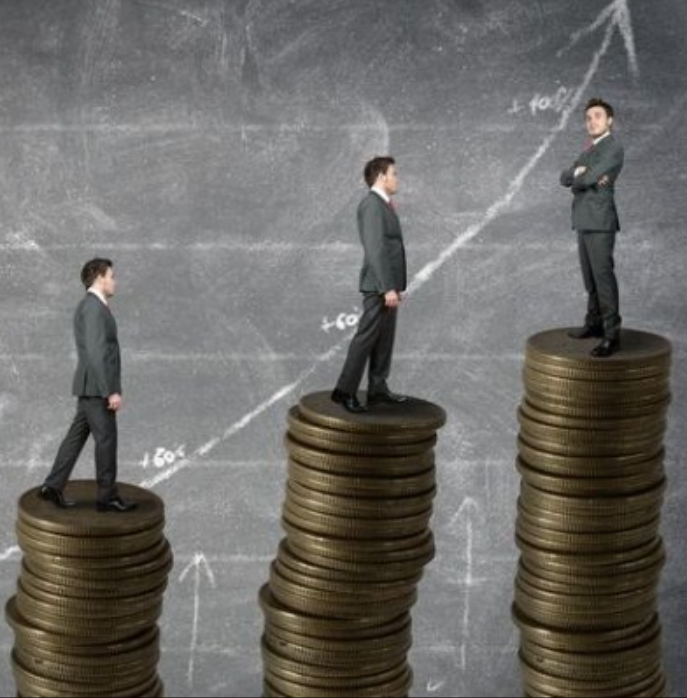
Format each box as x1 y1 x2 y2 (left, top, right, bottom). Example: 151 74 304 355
5 481 173 698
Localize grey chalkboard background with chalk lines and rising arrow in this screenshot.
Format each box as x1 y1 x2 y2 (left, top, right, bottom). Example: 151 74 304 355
0 0 687 696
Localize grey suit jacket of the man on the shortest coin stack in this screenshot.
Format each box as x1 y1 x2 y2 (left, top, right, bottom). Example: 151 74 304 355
72 293 122 398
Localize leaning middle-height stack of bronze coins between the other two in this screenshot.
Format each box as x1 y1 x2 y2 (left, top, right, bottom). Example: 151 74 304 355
260 393 446 698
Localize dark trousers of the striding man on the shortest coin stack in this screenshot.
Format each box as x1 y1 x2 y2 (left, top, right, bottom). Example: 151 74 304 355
45 397 117 502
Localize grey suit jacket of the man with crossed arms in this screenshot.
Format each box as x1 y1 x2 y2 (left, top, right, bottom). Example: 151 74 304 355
561 134 625 232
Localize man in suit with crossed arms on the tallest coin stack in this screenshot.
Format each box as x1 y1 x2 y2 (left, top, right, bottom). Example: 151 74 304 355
561 99 624 358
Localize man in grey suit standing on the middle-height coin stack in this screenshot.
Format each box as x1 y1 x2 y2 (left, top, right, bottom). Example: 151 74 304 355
331 157 408 413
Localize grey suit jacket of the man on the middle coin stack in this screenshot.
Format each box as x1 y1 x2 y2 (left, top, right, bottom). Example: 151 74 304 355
358 191 407 294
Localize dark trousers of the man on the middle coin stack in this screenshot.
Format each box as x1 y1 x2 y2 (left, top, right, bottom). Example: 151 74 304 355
337 293 398 395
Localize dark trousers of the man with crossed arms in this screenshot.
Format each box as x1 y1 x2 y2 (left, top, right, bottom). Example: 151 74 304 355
577 231 622 339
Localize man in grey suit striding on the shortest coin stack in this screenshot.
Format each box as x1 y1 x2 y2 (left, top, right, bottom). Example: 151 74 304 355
39 259 136 513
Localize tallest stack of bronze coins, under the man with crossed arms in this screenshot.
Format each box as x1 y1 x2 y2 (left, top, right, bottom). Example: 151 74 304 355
513 330 671 698
